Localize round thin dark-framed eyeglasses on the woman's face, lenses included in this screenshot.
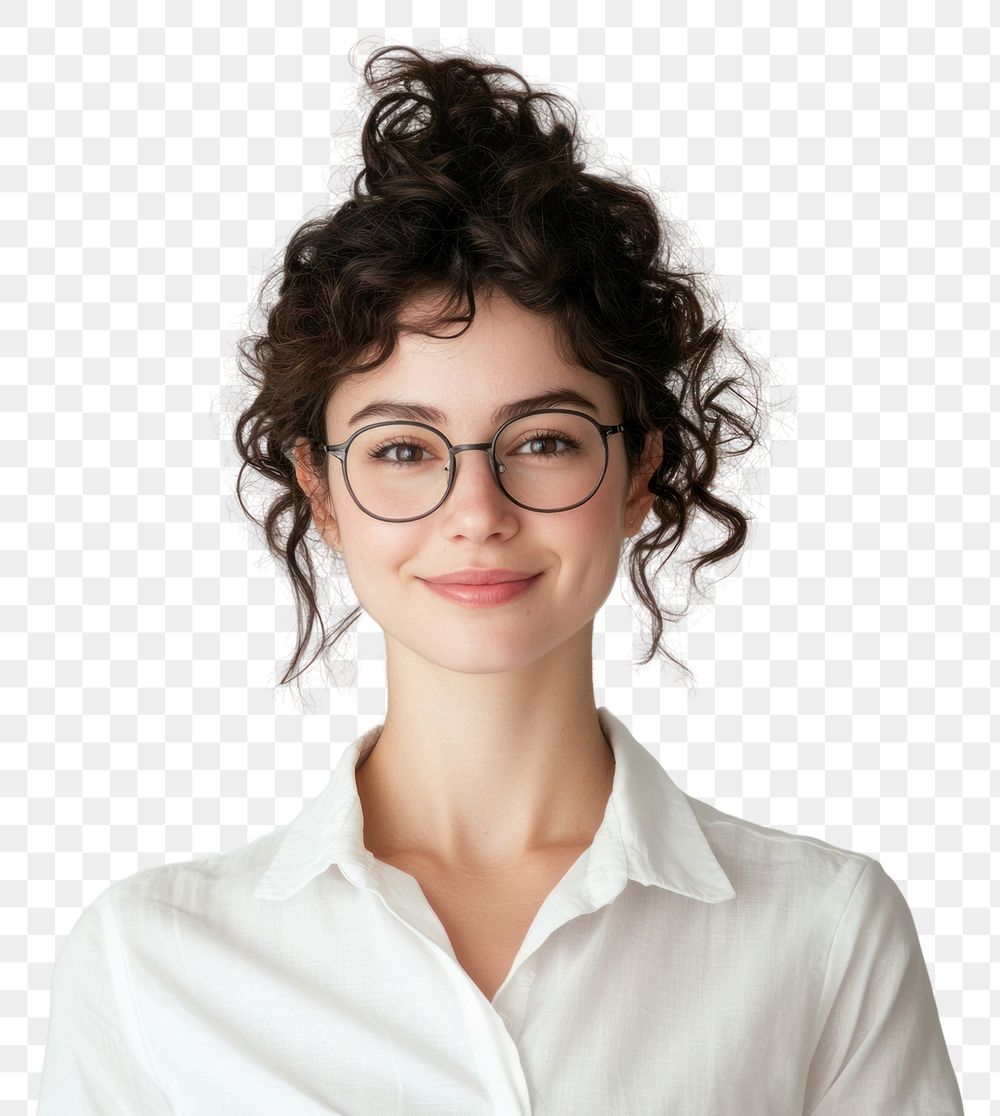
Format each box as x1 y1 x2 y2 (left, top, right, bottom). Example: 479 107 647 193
315 408 626 523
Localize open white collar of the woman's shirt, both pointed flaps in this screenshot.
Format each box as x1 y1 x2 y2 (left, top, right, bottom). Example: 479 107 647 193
253 705 735 903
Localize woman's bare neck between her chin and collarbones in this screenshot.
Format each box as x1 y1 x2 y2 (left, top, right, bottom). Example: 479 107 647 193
356 644 615 872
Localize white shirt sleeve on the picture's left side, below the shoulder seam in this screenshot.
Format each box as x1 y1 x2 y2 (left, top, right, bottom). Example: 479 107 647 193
37 885 173 1116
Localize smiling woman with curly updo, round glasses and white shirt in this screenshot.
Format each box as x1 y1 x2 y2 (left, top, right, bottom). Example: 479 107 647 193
40 39 961 1116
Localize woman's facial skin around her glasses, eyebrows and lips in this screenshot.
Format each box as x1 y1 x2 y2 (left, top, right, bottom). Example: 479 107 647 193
298 297 652 673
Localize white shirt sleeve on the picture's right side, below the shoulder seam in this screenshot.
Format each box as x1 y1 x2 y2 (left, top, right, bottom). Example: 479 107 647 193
804 859 963 1116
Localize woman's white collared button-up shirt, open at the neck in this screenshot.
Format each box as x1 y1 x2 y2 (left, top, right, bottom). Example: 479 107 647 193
38 706 962 1116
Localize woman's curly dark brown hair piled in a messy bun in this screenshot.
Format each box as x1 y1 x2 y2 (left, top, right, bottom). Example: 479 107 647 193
234 46 762 684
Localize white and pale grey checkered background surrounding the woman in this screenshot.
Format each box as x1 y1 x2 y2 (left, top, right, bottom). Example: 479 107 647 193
0 0 1000 1116
